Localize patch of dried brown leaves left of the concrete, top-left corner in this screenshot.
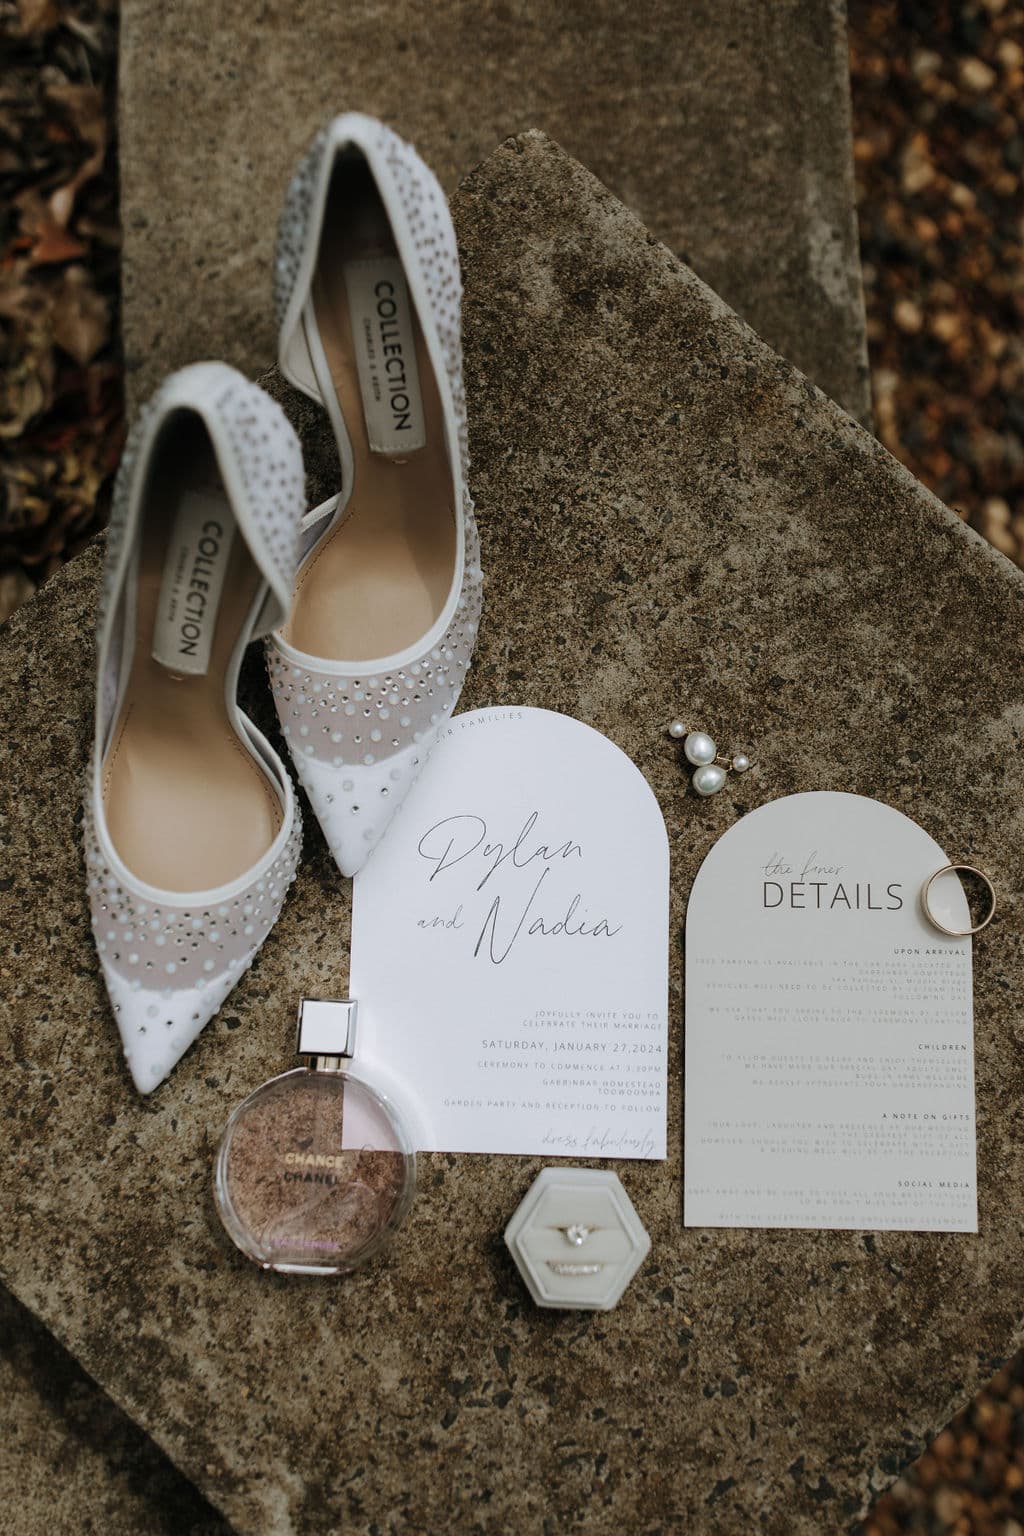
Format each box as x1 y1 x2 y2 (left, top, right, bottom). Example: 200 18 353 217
0 0 123 613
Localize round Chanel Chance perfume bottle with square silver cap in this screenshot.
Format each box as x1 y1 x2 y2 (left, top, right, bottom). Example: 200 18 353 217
213 998 416 1275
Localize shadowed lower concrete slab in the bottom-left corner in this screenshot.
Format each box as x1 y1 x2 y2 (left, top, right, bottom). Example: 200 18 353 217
0 1287 230 1536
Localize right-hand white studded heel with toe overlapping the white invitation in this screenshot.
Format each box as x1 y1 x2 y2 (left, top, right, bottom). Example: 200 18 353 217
267 112 482 874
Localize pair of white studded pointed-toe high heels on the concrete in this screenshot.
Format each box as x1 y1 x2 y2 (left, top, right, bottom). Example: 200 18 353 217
84 114 482 1092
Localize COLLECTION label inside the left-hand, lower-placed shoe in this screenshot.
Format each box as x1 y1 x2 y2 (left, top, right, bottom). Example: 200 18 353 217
152 490 235 677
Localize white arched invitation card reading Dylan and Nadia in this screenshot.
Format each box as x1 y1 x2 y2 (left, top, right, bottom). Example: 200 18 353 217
352 708 668 1158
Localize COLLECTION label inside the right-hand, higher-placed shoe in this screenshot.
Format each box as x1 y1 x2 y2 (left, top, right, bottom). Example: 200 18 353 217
345 257 427 456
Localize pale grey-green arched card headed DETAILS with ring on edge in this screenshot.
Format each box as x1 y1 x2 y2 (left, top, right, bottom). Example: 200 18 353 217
685 793 978 1232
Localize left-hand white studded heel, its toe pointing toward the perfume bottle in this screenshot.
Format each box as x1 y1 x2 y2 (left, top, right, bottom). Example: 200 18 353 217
84 362 304 1094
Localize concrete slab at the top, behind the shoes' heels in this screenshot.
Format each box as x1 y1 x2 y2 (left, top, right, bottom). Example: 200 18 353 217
120 0 869 419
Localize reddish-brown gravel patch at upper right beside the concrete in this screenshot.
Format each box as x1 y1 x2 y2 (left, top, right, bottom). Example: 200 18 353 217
849 0 1024 564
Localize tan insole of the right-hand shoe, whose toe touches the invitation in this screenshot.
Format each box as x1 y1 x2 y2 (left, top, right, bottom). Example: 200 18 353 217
284 161 456 660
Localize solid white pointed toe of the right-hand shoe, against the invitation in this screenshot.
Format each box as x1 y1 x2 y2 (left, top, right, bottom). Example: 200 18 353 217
295 743 430 876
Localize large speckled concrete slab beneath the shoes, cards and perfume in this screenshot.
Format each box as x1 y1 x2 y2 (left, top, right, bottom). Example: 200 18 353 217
0 135 1024 1536
